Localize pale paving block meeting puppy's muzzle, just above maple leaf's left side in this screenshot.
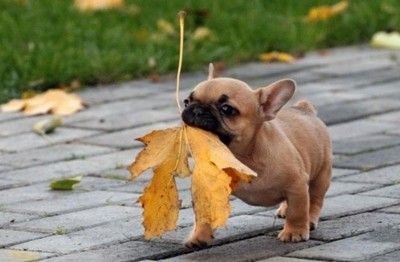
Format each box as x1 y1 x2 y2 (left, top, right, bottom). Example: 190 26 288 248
81 121 179 148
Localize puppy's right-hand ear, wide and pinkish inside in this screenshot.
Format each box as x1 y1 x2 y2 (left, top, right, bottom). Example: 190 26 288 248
256 79 296 121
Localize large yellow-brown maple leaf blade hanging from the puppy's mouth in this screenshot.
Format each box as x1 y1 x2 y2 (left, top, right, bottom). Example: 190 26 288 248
129 126 255 239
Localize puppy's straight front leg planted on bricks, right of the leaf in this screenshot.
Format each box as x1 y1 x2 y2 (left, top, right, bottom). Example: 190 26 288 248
278 184 310 242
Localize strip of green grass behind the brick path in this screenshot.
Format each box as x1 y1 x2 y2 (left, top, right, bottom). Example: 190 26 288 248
0 0 400 102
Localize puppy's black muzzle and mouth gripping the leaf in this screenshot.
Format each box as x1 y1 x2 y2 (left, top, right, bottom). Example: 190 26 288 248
182 103 234 145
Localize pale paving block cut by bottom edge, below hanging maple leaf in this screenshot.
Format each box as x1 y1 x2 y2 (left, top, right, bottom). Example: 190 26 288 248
43 241 181 262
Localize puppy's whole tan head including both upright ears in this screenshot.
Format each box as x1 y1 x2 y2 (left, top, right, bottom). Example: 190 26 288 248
182 65 295 145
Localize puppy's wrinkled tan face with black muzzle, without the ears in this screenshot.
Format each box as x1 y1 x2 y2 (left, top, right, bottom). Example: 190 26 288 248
182 78 260 145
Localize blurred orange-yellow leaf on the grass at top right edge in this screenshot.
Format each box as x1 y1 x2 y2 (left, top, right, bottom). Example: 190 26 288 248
305 1 349 22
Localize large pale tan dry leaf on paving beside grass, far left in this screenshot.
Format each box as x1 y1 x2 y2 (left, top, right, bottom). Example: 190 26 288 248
1 89 83 115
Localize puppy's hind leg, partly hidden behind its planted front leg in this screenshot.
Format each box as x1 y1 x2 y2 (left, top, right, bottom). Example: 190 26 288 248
309 164 332 230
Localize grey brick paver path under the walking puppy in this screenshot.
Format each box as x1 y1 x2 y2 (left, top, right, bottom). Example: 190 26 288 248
0 47 400 262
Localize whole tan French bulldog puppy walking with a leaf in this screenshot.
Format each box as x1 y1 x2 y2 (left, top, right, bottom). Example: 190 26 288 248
182 64 332 247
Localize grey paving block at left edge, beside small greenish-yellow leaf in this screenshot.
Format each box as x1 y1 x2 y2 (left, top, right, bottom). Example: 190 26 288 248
0 116 51 137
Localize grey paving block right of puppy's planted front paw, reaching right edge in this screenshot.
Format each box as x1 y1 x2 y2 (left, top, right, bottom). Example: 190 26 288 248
311 213 400 241
